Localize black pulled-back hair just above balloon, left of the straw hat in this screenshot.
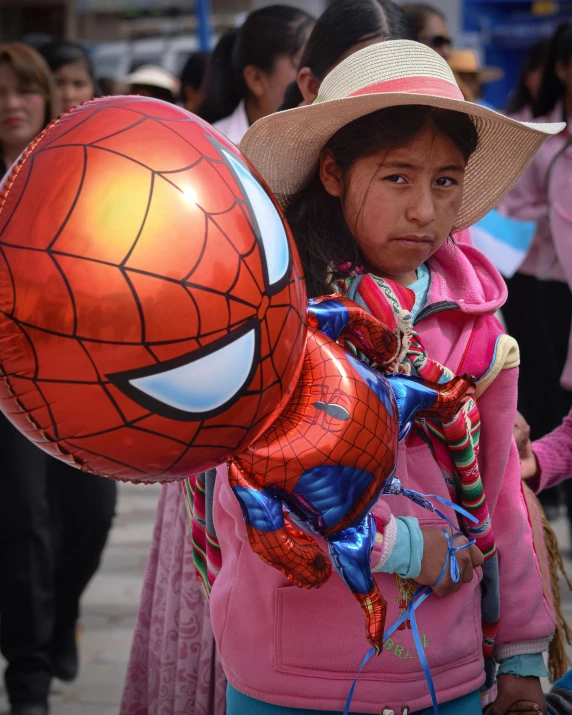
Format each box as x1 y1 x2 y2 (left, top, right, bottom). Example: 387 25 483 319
197 5 314 124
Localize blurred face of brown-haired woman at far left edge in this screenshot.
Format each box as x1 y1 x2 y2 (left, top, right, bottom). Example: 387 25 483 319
0 62 46 150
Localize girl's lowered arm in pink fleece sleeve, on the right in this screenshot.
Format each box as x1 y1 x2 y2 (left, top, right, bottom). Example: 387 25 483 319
478 368 554 712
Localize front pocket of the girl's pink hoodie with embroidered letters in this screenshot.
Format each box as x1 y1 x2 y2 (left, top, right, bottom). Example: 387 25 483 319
274 570 482 681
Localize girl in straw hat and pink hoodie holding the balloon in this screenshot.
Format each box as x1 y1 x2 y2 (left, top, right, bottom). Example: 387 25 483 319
211 41 559 715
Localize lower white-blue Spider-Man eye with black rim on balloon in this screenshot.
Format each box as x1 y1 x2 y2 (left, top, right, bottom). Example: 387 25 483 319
108 320 260 420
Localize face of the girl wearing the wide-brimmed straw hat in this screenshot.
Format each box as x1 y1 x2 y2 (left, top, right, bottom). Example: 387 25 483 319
320 127 465 285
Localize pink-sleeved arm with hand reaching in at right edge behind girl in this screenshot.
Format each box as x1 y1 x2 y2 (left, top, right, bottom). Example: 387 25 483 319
520 410 572 493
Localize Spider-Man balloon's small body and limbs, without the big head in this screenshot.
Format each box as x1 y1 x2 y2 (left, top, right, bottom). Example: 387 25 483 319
229 295 472 652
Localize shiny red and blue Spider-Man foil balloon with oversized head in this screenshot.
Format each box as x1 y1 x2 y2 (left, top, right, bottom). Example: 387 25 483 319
0 97 470 648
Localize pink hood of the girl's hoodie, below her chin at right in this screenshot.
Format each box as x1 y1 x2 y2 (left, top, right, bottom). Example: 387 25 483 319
426 241 508 315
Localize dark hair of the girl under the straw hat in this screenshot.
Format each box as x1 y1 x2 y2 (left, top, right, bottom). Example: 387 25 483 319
286 105 478 297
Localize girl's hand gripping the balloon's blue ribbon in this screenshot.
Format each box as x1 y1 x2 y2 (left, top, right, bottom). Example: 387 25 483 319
415 526 484 598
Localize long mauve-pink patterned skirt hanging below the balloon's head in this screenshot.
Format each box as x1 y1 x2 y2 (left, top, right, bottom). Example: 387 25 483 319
121 482 226 715
